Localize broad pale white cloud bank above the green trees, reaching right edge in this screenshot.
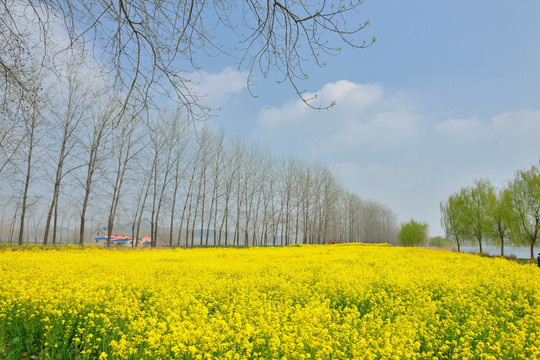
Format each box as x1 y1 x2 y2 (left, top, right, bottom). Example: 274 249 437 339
252 80 540 235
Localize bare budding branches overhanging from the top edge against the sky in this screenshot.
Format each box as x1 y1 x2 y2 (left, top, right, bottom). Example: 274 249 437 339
0 0 375 118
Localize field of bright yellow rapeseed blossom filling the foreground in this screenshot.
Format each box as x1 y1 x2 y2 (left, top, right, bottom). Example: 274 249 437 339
0 244 540 359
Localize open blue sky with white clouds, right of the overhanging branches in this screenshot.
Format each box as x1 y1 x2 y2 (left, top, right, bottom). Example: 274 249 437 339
195 0 540 235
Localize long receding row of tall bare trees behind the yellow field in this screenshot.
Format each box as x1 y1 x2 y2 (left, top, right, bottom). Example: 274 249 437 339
0 57 397 246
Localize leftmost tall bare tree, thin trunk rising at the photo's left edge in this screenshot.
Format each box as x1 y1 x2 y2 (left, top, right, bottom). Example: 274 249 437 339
0 28 46 245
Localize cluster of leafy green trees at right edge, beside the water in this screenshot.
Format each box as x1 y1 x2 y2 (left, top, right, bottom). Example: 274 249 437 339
440 161 540 258
